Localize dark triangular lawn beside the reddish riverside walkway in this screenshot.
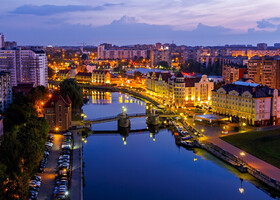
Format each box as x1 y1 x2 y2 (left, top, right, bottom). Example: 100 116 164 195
221 129 280 168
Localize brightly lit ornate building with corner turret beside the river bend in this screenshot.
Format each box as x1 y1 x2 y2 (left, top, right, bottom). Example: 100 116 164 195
146 72 214 108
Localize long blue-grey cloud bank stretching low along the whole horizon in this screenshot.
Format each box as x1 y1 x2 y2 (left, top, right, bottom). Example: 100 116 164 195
0 15 280 46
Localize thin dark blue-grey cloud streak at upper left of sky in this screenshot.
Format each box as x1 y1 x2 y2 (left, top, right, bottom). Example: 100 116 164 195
11 3 123 16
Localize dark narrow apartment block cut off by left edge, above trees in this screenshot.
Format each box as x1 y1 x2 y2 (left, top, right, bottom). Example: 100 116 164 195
0 71 13 111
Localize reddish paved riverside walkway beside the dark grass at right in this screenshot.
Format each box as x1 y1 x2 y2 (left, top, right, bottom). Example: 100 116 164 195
208 138 280 181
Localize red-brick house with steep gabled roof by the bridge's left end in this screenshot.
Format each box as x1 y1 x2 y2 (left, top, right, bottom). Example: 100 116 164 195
44 94 72 131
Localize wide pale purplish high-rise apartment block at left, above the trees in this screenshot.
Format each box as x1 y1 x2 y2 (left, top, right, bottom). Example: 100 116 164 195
0 49 48 86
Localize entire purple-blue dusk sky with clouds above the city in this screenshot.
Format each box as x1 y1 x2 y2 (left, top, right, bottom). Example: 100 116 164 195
0 0 280 45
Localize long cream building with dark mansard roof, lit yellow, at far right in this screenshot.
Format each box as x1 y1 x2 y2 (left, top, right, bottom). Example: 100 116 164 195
212 81 280 126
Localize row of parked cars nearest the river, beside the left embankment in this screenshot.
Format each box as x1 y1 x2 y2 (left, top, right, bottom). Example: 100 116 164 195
53 132 72 199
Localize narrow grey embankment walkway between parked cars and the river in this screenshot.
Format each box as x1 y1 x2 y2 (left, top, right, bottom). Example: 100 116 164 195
70 131 83 200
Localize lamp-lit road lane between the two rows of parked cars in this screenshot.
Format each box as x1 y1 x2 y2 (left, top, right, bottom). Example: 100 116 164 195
38 134 63 200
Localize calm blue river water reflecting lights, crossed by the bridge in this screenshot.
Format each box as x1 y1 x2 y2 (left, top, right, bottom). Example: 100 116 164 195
83 92 273 200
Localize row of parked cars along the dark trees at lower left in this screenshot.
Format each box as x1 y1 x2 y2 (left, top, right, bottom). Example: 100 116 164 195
27 135 54 200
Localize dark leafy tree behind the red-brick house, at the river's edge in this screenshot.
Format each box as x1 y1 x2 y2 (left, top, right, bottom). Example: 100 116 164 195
59 79 83 110
